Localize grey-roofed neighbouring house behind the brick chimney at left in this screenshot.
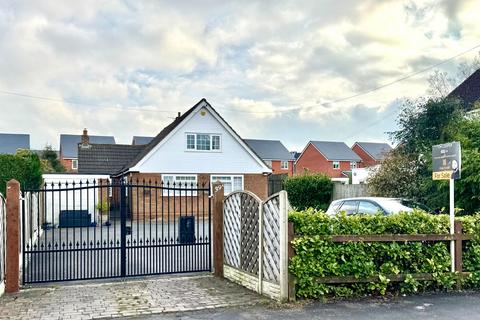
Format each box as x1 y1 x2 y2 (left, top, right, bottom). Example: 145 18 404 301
60 129 115 173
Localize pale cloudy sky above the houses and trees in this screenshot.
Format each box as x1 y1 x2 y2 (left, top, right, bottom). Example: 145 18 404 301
0 0 480 149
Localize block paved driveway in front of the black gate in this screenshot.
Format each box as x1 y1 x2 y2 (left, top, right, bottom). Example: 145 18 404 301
0 274 269 320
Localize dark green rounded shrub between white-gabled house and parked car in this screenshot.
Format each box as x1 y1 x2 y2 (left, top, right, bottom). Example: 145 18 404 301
284 174 333 210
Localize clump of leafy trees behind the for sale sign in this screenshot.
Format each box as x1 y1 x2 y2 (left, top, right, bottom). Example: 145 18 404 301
369 99 480 214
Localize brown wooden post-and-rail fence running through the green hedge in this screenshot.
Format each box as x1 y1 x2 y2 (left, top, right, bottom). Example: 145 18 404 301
288 221 473 290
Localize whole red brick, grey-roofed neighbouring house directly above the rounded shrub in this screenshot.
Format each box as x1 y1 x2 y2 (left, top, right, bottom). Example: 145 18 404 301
295 141 362 183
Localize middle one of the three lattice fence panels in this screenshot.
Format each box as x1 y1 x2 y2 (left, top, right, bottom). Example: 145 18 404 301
240 193 260 275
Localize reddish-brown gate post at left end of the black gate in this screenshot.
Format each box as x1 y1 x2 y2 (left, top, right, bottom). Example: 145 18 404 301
5 179 20 293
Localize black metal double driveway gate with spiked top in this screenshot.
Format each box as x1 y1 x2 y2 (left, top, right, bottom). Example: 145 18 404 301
22 179 211 284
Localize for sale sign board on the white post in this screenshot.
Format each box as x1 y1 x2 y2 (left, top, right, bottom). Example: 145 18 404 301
432 142 462 180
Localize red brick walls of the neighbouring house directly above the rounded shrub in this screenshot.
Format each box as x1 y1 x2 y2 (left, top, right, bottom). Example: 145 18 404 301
296 144 360 178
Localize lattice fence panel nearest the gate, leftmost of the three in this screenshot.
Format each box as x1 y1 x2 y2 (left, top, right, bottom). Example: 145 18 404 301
223 193 241 268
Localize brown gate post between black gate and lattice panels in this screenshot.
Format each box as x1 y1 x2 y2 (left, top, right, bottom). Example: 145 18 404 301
212 181 224 277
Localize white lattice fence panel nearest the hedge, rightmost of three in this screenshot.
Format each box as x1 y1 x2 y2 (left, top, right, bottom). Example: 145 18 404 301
263 195 280 283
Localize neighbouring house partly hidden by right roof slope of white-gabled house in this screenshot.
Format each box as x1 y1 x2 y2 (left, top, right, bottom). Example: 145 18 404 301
244 139 295 176
